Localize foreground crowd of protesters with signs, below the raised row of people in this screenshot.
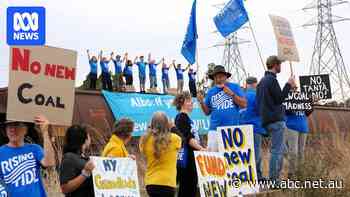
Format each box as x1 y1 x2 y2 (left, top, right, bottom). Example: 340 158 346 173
0 56 308 197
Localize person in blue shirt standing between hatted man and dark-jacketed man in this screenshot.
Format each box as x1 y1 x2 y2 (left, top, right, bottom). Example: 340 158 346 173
240 77 267 180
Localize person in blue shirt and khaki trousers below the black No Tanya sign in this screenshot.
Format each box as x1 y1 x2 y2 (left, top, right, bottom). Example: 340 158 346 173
285 101 312 178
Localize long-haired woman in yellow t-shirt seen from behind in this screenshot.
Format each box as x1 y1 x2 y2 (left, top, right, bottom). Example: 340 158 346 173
140 112 181 197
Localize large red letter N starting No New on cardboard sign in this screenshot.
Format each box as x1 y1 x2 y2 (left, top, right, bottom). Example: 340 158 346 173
12 48 30 72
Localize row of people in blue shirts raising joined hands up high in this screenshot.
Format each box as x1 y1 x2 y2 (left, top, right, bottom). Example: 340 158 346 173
87 50 197 97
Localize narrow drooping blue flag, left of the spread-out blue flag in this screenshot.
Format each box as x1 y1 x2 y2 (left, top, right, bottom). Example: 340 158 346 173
181 0 198 64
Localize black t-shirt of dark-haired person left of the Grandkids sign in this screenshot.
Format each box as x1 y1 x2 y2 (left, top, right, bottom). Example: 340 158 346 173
60 152 94 197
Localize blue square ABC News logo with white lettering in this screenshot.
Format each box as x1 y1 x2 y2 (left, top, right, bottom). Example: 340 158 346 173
7 7 46 45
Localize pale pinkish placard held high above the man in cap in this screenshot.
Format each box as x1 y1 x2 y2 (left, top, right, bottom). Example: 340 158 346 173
269 15 300 62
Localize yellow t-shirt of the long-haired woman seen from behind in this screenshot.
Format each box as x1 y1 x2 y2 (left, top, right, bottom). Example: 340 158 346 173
140 133 181 188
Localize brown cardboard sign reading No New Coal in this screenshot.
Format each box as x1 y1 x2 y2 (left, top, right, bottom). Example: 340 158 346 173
7 46 77 126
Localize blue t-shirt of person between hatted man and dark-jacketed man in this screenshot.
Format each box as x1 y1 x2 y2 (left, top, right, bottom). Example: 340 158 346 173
240 89 266 135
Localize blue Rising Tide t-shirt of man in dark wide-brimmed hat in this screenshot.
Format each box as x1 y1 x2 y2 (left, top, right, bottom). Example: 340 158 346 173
204 83 244 131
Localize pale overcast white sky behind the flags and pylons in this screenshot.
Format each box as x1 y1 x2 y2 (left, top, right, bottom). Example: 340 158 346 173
0 0 350 93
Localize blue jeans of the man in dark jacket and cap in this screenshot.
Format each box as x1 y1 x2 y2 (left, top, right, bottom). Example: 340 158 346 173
266 121 286 180
